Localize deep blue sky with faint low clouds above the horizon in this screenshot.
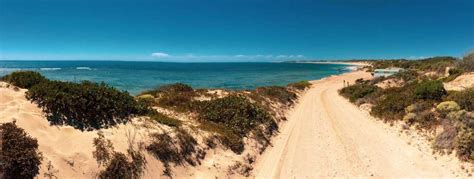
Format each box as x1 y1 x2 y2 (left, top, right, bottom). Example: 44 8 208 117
0 0 474 61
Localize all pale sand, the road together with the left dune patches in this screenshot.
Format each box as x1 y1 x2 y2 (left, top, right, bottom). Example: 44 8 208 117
0 72 465 178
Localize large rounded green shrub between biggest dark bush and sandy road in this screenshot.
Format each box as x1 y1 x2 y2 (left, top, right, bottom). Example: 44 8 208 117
199 95 277 135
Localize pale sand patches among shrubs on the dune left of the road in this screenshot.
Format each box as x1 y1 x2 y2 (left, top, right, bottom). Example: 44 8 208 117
0 82 241 178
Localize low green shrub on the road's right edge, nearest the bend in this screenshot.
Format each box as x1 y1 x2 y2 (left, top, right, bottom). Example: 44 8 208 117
339 83 379 102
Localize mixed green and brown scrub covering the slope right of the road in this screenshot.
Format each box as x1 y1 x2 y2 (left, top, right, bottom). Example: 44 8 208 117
340 53 474 162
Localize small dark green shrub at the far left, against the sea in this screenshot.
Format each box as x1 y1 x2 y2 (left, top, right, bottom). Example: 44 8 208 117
2 71 47 89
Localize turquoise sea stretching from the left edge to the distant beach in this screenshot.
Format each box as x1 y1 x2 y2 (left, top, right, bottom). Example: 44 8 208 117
0 61 350 94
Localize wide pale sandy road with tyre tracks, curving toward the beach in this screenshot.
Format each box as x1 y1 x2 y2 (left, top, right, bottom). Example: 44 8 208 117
254 72 462 178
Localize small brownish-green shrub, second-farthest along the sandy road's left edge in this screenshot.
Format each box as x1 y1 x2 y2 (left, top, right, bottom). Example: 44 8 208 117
255 86 298 104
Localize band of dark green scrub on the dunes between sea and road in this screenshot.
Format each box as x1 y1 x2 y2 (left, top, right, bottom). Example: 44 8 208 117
1 71 311 178
